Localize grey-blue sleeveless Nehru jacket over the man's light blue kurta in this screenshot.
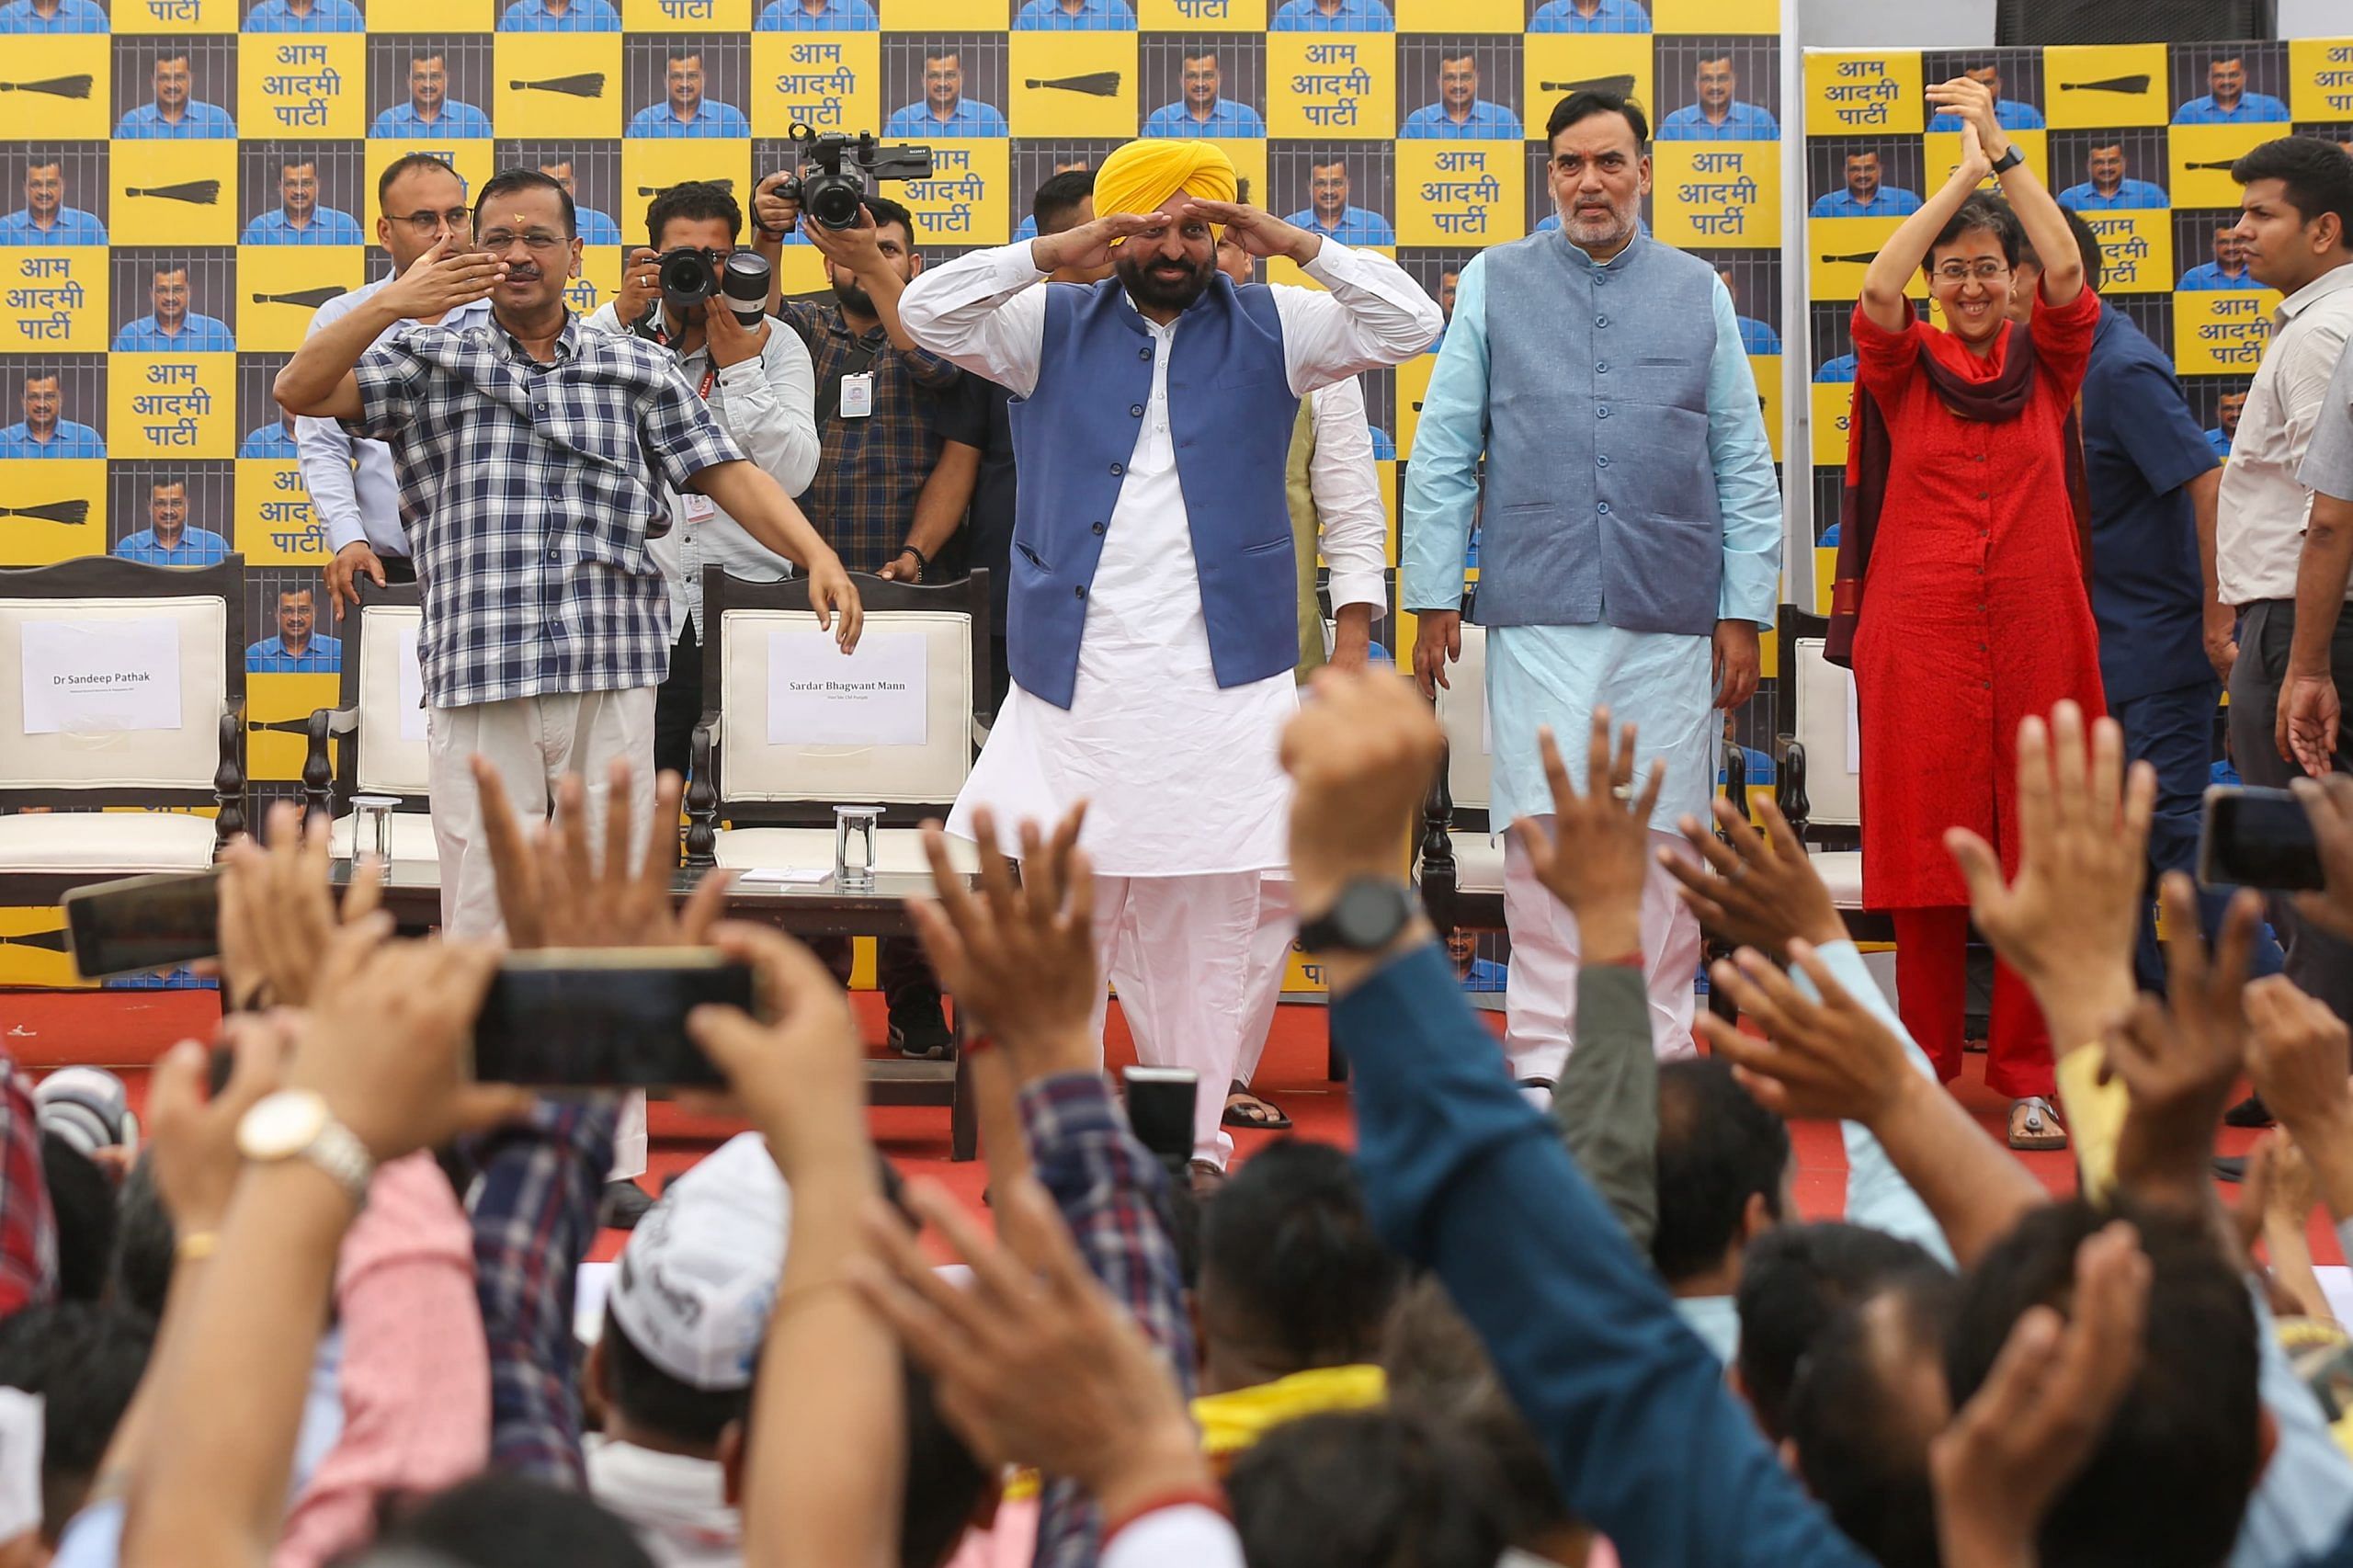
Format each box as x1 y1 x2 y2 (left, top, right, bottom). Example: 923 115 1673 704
1478 231 1724 636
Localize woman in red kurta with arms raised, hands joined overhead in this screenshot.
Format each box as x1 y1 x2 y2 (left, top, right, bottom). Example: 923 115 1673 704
1854 78 2104 1149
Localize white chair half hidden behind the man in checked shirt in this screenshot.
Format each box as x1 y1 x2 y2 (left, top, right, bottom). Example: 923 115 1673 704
301 584 440 867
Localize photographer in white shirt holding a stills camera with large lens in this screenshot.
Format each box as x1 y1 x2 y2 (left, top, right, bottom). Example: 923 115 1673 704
588 179 824 775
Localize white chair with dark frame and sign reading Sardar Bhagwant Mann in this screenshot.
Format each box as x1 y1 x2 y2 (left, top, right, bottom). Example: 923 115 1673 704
688 567 995 873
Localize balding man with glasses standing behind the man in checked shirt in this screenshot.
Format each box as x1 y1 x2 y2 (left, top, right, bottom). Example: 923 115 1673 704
294 153 489 621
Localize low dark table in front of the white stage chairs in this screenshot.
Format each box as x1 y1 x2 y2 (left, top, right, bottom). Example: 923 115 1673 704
332 859 979 1161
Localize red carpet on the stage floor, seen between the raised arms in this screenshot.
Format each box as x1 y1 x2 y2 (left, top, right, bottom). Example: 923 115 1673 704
0 991 2344 1265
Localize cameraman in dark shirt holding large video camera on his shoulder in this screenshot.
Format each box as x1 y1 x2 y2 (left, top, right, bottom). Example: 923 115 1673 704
753 137 988 1057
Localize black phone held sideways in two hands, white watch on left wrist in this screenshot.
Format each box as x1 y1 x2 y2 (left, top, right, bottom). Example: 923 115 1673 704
473 949 753 1087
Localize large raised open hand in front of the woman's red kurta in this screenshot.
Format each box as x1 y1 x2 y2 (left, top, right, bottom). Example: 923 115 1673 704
1944 706 2158 1052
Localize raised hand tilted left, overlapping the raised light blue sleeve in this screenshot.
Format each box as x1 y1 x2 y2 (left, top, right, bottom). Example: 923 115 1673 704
1694 942 1934 1128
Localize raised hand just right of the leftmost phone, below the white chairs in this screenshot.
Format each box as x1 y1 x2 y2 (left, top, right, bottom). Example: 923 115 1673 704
222 801 383 1007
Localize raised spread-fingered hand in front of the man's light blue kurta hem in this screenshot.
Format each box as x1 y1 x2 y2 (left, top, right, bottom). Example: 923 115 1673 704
1511 706 1665 963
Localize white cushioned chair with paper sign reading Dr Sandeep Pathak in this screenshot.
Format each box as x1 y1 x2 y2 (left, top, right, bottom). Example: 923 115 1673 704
0 556 247 904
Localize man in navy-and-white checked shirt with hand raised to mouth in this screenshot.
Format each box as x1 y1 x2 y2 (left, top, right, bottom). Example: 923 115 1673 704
276 169 858 937
